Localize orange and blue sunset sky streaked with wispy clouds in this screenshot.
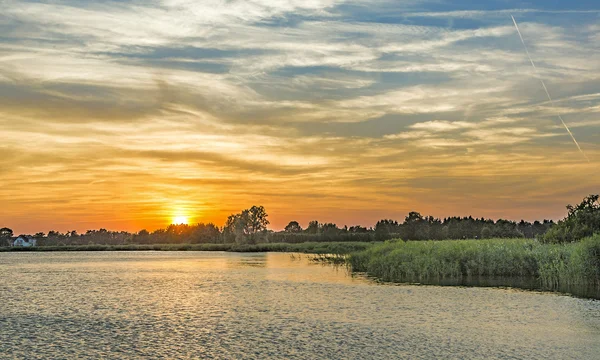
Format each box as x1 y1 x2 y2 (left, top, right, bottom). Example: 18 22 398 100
0 0 600 233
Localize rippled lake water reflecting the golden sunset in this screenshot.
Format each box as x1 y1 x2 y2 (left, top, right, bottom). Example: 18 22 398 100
0 252 600 359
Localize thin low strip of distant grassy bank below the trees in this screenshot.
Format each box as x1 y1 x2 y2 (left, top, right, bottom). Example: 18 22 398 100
0 242 372 254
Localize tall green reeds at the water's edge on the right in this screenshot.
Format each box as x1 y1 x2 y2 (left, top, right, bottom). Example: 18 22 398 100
348 235 600 289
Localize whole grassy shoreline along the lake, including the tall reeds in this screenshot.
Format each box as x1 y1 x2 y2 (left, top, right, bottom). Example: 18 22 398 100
0 237 600 300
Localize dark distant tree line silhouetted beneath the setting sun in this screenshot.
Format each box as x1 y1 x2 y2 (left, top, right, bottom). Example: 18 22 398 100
0 206 576 246
